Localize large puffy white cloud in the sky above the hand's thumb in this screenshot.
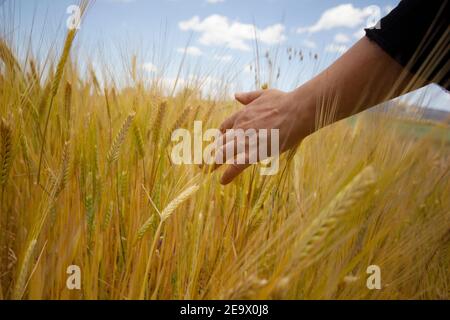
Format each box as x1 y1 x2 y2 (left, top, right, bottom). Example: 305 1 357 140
178 14 286 51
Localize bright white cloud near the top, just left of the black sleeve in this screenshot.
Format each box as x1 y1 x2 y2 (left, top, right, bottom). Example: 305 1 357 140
297 3 374 33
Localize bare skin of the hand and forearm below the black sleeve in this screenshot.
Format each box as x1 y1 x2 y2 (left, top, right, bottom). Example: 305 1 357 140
216 37 427 185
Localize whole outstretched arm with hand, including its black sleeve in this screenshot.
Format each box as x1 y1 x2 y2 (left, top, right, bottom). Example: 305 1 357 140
219 0 450 184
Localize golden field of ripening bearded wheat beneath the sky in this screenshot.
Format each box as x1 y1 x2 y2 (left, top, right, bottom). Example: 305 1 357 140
0 1 450 299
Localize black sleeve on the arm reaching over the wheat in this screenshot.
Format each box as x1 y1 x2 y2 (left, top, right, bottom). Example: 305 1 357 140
365 0 450 90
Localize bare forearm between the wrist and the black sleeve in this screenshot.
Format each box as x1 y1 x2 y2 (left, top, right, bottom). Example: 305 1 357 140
293 37 426 131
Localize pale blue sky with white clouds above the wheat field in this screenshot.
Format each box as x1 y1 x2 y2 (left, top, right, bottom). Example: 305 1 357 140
0 0 450 111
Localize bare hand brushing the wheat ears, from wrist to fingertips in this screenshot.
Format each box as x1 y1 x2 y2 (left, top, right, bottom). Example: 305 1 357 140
216 88 315 184
